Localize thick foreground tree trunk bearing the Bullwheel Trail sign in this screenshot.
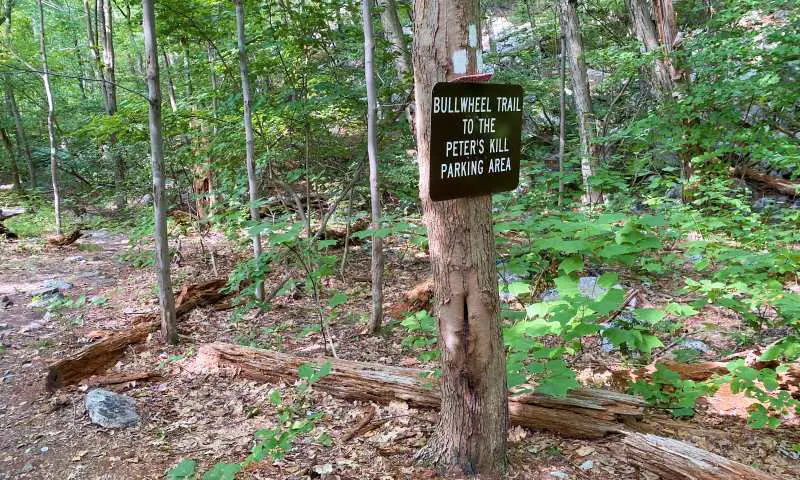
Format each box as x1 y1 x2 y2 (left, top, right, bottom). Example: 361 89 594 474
413 0 508 474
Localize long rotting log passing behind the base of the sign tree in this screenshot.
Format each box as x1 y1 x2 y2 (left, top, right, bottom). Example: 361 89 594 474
196 343 644 438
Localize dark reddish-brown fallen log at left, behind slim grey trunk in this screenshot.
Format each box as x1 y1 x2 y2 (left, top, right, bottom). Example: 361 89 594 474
45 280 227 392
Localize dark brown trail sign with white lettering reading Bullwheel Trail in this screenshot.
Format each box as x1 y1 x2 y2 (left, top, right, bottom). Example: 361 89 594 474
429 82 522 200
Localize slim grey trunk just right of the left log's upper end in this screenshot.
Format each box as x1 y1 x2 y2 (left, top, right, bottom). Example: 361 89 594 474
233 0 264 300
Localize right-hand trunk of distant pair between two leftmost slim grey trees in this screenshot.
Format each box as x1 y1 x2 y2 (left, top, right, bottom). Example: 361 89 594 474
98 0 125 210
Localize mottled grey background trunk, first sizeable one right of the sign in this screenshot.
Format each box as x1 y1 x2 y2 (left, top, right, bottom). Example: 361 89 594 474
559 0 603 205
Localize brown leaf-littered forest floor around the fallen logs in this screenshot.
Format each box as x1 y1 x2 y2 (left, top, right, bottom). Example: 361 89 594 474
0 226 800 480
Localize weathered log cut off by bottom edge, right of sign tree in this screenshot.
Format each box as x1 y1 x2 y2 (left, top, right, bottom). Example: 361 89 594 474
621 432 774 480
